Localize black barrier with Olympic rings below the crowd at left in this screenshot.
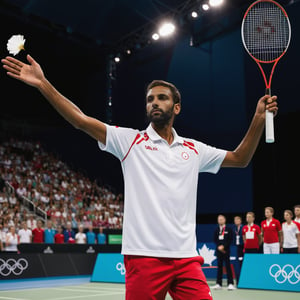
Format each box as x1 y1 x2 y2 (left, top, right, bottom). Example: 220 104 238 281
0 253 97 280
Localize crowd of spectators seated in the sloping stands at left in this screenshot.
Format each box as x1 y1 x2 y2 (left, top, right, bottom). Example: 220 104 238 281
0 139 123 251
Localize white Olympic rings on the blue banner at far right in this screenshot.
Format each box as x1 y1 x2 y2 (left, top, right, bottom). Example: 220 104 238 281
269 264 300 284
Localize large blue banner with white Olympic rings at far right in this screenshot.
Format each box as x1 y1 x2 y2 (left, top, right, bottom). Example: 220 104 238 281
238 254 300 292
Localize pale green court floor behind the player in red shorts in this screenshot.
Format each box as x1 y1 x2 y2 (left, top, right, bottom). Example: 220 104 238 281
0 281 300 300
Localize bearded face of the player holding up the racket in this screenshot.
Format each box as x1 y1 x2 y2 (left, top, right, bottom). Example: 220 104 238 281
146 86 180 127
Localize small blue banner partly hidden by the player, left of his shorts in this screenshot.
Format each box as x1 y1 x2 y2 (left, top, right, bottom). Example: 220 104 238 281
91 253 125 283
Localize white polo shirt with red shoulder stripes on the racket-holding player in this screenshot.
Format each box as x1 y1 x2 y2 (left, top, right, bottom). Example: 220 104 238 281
98 125 226 258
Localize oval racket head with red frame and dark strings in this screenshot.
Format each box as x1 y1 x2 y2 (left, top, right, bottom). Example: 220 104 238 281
241 0 291 63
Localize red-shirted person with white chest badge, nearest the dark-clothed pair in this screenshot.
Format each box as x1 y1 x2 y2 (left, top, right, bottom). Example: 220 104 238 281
243 211 262 253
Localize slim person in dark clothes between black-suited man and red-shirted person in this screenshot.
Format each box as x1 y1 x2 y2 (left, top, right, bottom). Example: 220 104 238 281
233 216 244 284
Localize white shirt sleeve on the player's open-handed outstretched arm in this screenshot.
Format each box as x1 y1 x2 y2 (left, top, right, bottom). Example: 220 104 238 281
98 124 139 160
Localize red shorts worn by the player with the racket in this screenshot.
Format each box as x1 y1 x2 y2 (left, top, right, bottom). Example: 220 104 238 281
124 255 212 300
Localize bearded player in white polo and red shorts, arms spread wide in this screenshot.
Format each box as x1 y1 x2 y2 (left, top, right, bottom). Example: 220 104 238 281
2 55 278 300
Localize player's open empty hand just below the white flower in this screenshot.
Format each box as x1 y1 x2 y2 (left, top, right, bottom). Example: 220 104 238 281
1 55 45 88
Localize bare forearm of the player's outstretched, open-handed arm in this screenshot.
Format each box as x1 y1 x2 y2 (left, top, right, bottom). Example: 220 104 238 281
38 78 85 128
